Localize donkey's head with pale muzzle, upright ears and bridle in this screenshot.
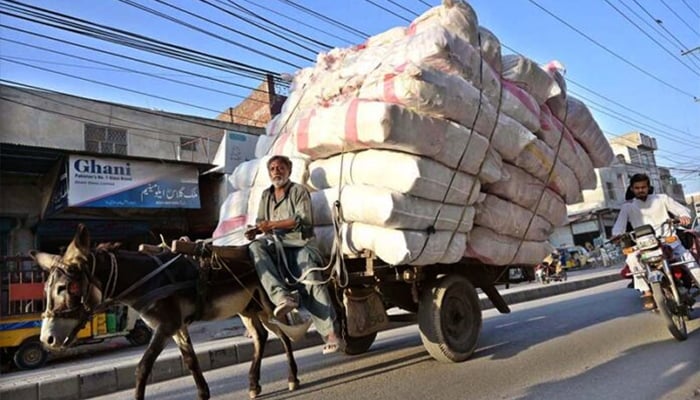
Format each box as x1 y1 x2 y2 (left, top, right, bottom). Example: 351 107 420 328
30 224 100 350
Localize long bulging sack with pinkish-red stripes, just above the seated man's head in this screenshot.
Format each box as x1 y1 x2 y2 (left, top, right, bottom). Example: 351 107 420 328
289 100 488 175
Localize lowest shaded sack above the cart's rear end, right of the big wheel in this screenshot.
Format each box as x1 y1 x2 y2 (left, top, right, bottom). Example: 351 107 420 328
464 226 554 265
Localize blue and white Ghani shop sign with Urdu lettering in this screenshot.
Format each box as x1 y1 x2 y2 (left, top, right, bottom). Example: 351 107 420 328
66 155 200 208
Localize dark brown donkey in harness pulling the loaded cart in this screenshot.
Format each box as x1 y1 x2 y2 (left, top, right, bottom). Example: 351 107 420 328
31 224 308 400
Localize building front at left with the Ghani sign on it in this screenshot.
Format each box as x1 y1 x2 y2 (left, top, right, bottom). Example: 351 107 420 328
0 85 264 255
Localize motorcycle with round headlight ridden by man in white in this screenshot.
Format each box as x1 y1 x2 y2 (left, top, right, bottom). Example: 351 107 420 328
615 220 700 341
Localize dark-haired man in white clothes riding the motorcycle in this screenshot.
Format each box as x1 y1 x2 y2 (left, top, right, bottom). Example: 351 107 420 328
612 174 700 310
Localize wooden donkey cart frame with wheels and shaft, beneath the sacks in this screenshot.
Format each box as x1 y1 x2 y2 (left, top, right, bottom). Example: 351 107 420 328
171 241 534 362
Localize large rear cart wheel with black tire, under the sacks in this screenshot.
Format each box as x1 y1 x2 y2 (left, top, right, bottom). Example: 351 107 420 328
418 275 481 362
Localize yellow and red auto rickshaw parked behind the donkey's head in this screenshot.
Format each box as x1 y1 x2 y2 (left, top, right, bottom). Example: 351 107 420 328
0 257 152 369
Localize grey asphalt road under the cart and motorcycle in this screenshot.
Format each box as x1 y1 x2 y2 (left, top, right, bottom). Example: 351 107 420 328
87 281 700 400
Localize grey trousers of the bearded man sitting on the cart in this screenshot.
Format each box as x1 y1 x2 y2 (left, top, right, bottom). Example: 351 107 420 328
248 239 337 338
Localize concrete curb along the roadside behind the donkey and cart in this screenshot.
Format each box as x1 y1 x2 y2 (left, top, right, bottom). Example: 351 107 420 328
0 271 620 400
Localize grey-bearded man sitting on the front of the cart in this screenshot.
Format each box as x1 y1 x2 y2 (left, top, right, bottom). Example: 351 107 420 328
246 155 341 354
